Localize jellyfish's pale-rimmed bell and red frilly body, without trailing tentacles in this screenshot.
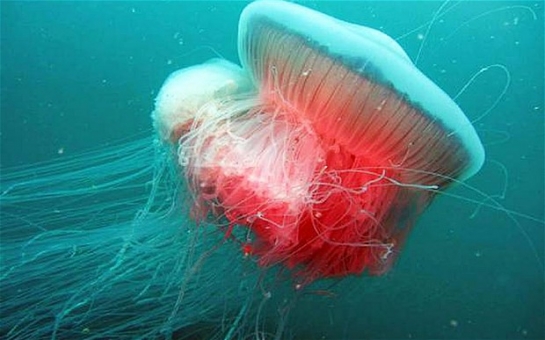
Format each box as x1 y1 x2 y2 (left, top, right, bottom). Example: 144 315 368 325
156 1 484 282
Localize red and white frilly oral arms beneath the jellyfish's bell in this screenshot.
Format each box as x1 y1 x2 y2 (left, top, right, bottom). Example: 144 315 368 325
179 92 430 282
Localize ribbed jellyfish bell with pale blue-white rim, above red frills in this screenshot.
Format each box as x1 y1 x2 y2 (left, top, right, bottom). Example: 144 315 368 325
239 1 484 179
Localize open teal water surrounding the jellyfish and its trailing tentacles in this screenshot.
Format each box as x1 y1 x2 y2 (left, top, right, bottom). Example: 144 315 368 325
0 1 545 339
